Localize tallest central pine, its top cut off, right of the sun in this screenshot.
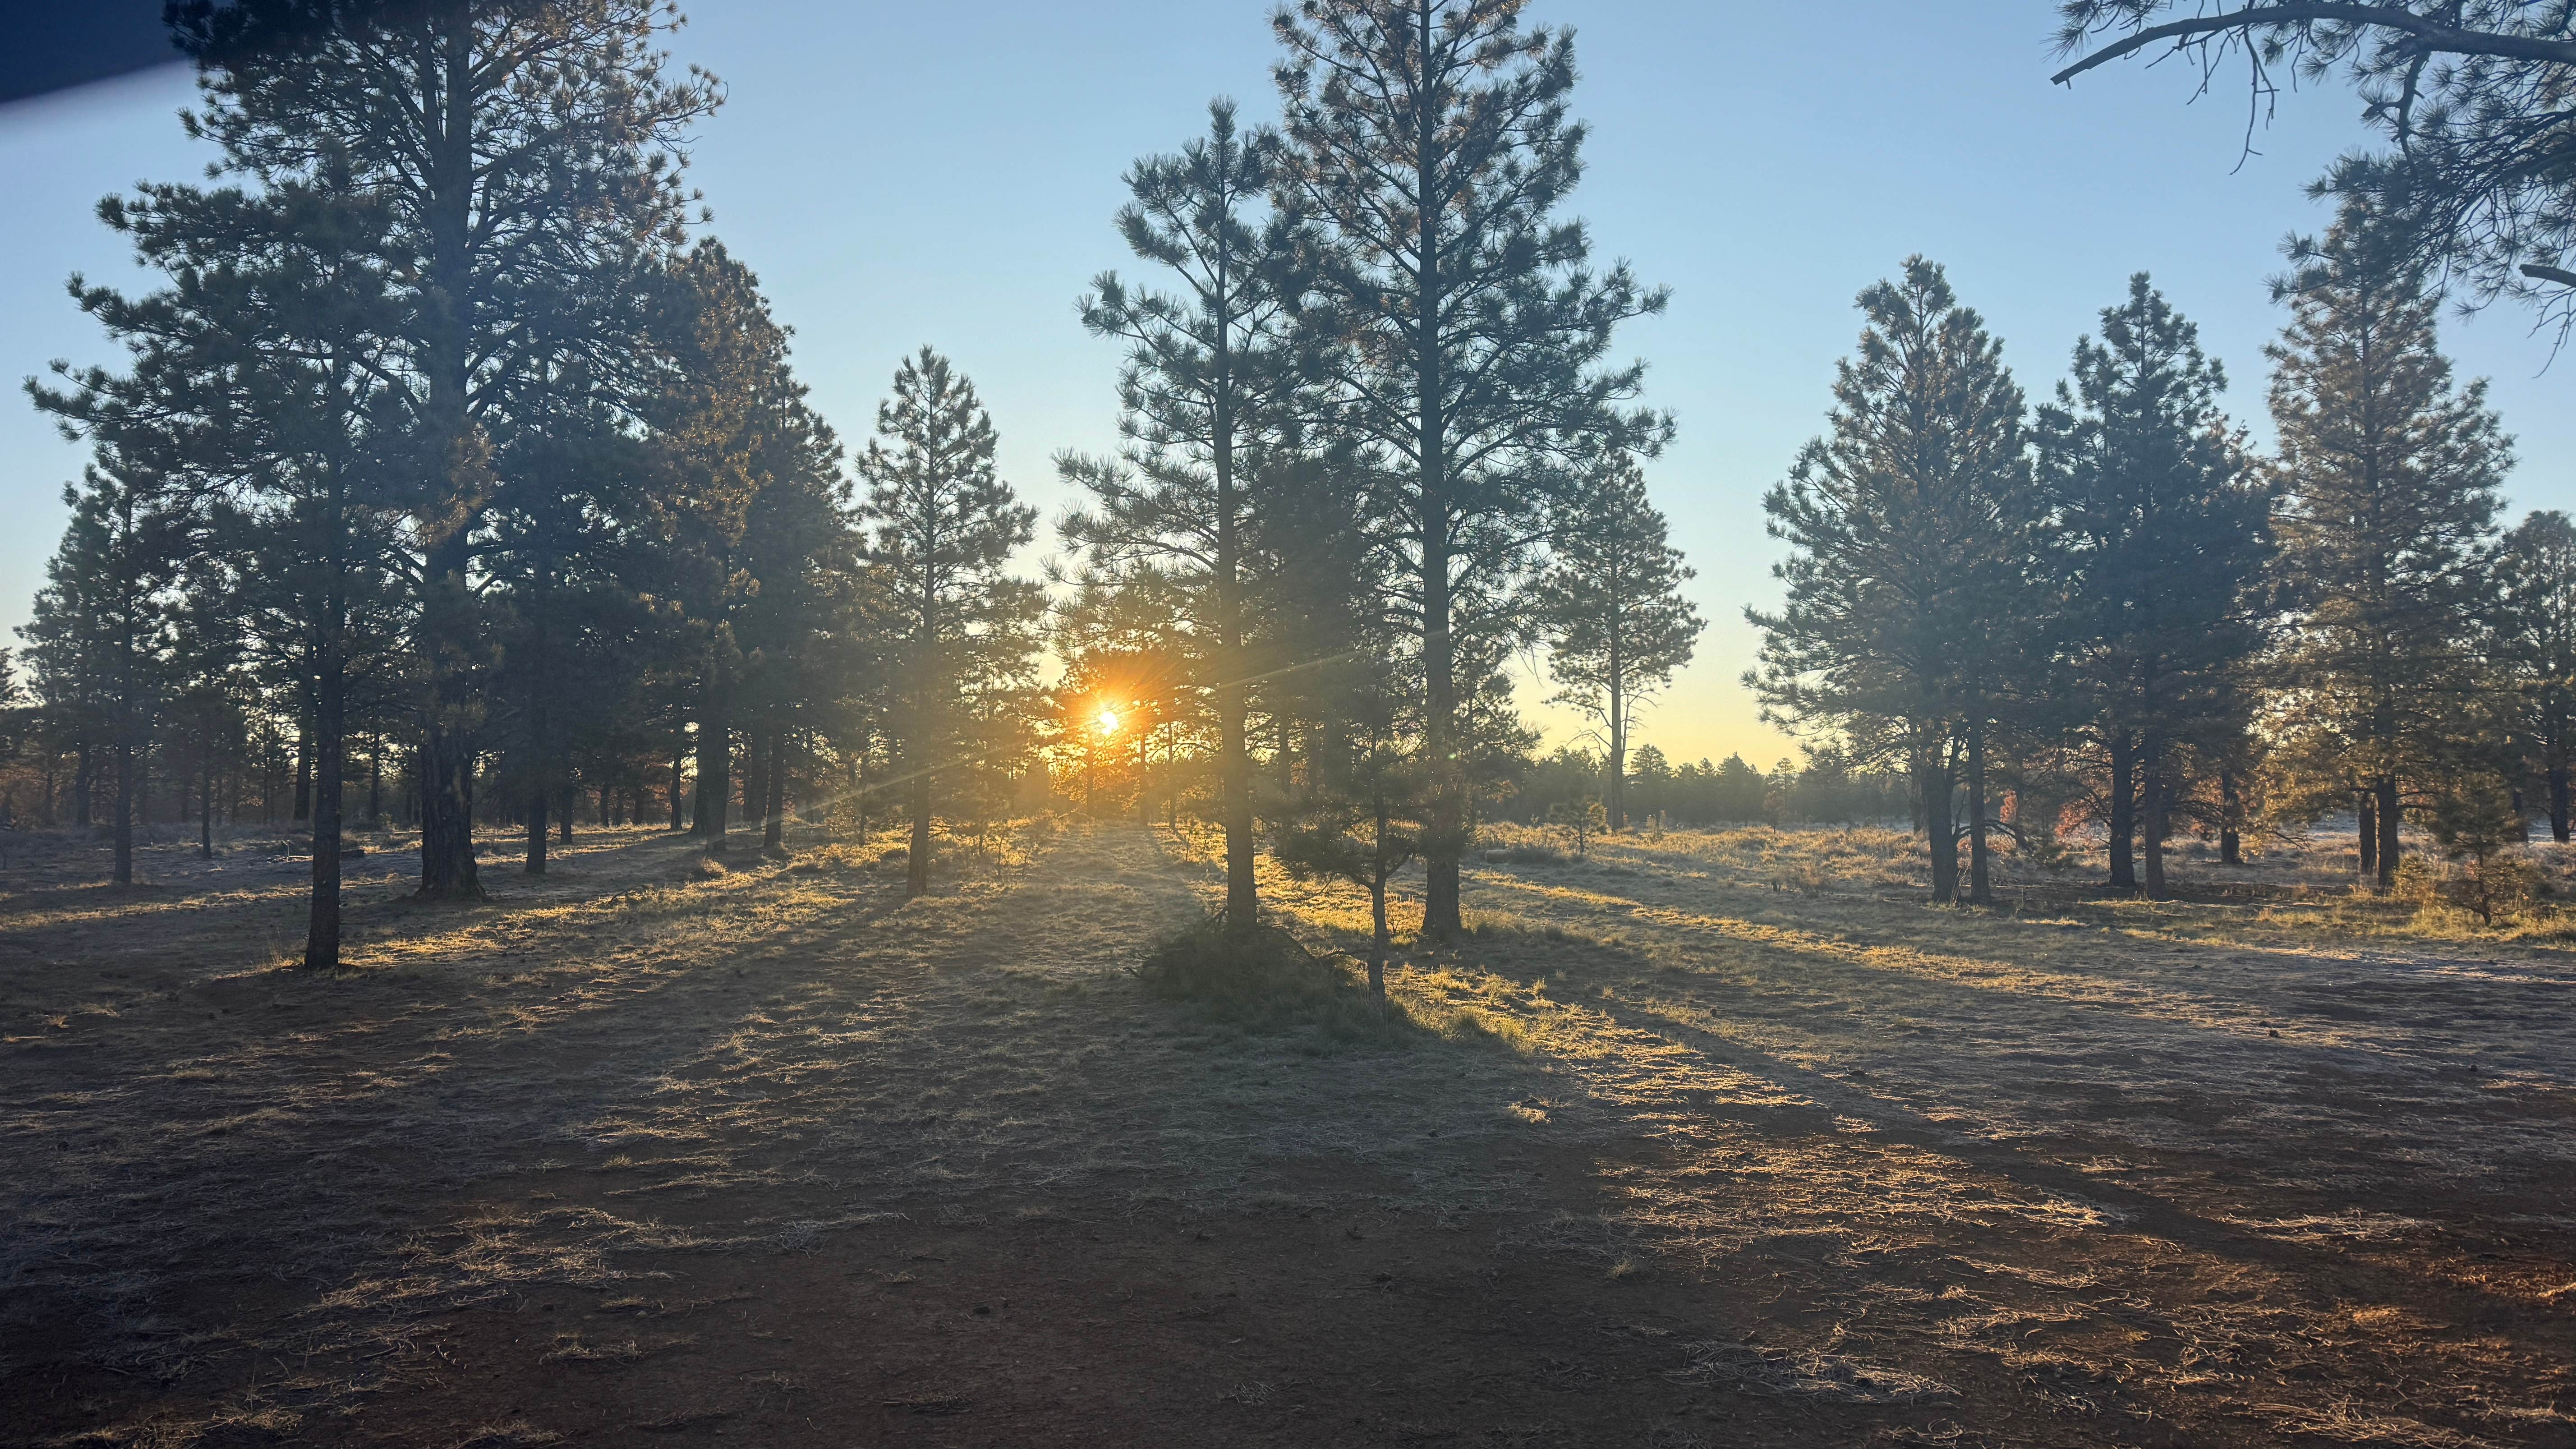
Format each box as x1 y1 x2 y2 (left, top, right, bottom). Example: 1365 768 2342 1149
1273 0 1669 936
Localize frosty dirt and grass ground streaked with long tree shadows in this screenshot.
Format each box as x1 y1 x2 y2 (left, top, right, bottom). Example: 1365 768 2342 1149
0 825 2576 1449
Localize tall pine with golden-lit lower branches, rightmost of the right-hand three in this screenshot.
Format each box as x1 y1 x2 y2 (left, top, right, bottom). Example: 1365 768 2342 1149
2267 209 2512 889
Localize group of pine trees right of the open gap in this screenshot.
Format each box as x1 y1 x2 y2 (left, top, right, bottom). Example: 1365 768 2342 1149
1747 201 2576 900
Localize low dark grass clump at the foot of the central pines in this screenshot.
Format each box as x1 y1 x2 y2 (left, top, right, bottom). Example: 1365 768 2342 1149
1136 913 1417 1044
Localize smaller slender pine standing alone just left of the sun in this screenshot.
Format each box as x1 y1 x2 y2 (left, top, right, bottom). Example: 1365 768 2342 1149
858 348 1046 895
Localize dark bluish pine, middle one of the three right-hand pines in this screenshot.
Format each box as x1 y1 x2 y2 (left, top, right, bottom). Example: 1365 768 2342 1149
2038 271 2272 900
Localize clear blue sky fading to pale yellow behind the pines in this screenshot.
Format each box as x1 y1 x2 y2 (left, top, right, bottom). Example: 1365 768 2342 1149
0 0 2576 763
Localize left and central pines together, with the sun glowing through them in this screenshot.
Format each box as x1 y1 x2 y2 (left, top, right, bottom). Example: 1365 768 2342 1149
5 0 1700 967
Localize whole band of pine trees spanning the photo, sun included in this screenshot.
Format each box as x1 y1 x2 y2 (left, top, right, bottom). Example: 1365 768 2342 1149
0 0 2576 967
